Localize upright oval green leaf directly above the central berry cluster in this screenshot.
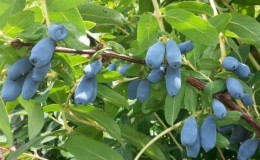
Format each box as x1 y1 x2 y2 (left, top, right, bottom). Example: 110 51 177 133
137 12 159 50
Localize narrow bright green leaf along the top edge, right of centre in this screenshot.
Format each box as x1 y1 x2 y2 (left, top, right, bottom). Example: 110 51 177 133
165 1 213 16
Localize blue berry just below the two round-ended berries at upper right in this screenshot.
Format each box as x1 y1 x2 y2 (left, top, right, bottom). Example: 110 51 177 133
226 78 244 99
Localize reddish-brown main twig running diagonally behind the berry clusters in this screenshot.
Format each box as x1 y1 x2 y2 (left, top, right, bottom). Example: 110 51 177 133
11 40 260 135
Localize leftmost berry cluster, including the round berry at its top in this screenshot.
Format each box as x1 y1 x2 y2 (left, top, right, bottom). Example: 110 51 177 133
1 24 68 101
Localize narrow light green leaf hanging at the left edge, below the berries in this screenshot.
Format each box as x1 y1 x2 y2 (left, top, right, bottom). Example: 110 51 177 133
0 97 13 146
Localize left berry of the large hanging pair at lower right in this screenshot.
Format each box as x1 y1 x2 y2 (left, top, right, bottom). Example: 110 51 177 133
181 116 198 146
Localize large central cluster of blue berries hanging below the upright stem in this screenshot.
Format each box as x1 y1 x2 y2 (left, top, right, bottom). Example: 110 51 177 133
126 40 194 102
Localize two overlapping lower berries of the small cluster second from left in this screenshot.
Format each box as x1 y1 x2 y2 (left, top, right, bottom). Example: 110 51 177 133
74 77 96 104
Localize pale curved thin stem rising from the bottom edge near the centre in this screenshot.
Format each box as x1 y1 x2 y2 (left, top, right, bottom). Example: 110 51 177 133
134 122 182 160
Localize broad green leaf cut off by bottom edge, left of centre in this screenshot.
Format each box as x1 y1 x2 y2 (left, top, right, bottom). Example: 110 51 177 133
64 134 123 160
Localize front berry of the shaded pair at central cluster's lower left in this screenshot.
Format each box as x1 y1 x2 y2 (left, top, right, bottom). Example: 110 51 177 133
136 80 151 102
